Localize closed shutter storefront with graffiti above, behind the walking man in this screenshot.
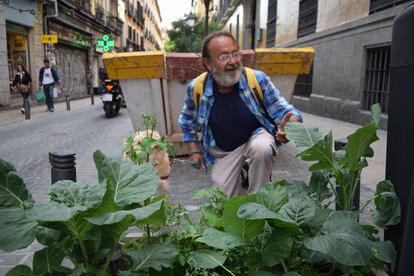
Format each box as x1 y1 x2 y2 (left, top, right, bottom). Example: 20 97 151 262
48 21 92 98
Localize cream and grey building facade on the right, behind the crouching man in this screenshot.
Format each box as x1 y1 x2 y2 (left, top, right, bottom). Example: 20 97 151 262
216 0 414 128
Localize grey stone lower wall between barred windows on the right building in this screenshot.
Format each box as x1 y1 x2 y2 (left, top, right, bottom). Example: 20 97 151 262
281 5 407 128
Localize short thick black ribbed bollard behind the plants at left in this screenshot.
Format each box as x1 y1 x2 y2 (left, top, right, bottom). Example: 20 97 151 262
49 150 76 184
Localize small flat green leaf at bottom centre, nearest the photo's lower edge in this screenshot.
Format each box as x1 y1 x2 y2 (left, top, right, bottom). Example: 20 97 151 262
187 249 226 269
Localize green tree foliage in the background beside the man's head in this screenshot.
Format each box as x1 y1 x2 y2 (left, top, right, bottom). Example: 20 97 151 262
164 14 222 53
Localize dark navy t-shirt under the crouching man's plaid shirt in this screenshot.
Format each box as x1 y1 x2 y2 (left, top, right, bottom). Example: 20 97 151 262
209 84 261 151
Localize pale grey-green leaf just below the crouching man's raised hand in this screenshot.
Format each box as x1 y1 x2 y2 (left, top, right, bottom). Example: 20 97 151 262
285 122 324 152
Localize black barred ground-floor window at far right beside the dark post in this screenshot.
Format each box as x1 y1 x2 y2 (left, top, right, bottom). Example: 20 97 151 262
362 46 391 113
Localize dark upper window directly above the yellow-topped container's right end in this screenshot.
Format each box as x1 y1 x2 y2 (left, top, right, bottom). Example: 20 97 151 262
298 0 318 37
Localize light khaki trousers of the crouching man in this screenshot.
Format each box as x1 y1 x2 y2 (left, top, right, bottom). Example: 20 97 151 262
210 129 277 197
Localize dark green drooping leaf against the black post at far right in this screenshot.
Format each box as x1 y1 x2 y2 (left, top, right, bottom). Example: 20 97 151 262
371 180 401 228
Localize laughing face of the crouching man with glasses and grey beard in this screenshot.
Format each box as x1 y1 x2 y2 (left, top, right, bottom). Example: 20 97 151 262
203 36 243 87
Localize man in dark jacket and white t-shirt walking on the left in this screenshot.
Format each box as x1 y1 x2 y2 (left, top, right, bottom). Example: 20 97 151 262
39 58 62 112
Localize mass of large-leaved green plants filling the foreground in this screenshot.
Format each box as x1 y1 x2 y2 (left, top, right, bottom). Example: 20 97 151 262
0 104 400 276
